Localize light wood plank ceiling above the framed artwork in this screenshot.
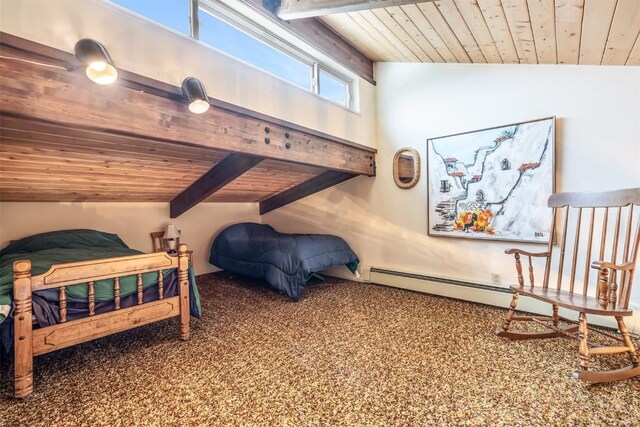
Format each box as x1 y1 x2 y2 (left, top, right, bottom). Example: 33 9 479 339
320 0 640 65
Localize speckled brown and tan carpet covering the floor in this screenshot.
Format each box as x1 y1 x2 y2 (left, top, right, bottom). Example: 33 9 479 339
0 274 640 426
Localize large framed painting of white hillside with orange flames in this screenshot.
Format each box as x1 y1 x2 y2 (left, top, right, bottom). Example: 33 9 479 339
427 117 555 243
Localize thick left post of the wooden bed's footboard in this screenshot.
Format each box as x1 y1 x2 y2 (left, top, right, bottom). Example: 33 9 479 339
13 261 33 398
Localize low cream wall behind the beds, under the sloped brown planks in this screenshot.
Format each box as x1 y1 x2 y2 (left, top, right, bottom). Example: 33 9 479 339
0 203 260 274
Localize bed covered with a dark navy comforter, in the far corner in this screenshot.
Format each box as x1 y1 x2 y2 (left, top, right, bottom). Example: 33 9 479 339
209 222 360 301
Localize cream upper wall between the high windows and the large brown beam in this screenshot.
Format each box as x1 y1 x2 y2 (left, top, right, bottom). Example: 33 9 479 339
0 0 375 146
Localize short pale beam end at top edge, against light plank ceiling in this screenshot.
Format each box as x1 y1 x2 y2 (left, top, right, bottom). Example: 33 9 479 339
276 0 433 20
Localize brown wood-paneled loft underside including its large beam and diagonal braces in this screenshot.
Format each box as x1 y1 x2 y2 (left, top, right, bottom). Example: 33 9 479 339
0 34 376 217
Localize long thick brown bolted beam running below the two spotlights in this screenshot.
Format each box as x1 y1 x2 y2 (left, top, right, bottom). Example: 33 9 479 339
0 33 376 176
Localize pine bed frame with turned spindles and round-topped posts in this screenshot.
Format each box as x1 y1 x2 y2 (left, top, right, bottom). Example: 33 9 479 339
13 244 190 398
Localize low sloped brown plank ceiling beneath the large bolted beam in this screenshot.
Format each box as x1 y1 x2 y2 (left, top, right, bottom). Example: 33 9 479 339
0 116 324 202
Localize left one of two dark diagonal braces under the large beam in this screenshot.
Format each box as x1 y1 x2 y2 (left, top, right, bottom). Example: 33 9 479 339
169 154 262 218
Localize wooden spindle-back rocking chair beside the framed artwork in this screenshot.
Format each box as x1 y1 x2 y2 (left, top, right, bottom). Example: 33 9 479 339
496 188 640 382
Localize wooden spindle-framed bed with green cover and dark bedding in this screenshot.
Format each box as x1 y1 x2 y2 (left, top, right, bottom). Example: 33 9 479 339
0 230 200 398
